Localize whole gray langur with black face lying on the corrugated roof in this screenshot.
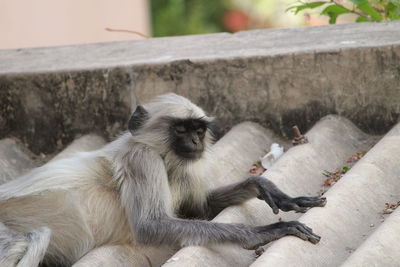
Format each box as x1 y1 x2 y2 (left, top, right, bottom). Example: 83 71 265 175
0 94 326 266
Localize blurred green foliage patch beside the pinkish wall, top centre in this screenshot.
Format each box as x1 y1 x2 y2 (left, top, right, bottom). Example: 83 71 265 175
151 0 227 37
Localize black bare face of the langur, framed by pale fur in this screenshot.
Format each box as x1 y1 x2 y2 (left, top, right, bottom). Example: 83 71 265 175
171 119 207 159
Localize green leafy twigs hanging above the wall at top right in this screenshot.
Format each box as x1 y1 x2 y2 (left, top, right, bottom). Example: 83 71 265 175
287 0 400 24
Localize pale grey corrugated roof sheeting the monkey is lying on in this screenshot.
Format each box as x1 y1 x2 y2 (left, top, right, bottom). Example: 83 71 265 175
0 116 400 267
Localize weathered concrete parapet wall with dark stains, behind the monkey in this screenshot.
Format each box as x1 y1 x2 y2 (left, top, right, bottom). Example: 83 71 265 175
0 22 400 153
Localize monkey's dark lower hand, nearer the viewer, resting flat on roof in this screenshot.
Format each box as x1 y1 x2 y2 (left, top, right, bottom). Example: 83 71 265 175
243 221 321 249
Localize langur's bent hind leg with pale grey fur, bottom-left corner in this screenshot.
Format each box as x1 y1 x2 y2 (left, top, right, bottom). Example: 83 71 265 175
0 223 51 267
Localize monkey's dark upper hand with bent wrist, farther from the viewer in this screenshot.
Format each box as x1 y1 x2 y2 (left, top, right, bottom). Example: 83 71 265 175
251 176 326 214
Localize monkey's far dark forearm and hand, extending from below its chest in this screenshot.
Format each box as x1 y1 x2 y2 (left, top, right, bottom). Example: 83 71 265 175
207 176 326 218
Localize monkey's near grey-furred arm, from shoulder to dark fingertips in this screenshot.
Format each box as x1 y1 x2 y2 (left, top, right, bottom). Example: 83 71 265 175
115 145 319 248
